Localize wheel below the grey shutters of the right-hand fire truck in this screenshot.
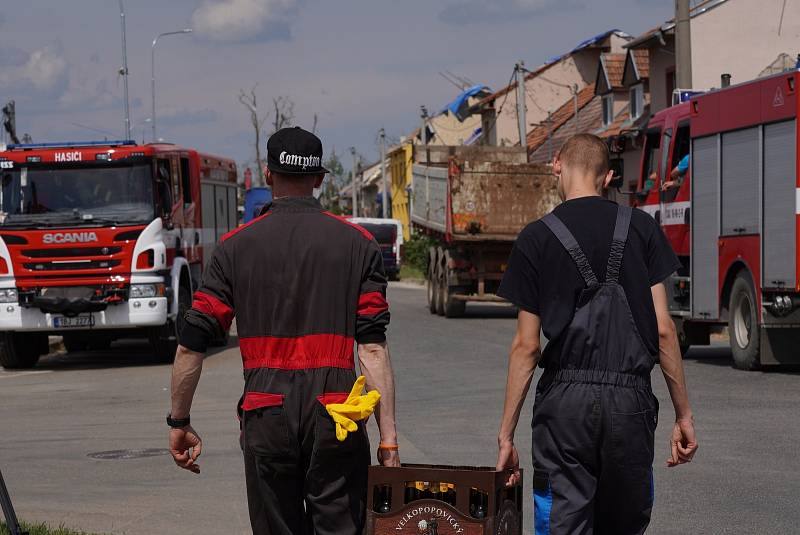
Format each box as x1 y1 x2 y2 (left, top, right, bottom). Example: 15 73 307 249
728 272 761 370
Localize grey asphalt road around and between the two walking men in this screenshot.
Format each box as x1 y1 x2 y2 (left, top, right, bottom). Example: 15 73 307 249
0 284 800 534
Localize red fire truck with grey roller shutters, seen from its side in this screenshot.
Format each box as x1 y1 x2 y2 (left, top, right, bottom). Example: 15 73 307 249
634 71 800 369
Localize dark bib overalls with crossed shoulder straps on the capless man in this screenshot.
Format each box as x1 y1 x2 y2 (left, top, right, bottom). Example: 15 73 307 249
533 207 658 535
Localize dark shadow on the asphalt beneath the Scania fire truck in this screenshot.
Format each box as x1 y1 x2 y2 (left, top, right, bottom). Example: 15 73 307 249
34 335 239 372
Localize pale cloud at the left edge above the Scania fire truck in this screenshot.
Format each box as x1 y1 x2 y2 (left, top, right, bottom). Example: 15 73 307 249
0 47 69 97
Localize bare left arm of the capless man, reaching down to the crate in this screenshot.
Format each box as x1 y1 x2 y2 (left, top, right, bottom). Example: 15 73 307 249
497 310 541 485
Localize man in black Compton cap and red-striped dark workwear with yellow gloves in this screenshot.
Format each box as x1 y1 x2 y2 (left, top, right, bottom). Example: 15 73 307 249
167 128 400 535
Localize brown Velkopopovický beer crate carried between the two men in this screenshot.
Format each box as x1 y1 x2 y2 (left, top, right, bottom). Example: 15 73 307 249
365 464 522 535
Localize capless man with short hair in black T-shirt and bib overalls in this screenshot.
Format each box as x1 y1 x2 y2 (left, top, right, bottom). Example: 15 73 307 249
497 134 697 535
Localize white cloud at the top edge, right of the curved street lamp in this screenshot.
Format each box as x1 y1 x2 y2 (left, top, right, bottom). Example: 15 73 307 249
192 0 299 43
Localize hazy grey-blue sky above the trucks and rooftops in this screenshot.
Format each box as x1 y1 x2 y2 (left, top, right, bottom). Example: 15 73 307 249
0 0 674 172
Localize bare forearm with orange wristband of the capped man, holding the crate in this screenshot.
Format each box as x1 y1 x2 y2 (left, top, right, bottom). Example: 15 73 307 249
358 342 400 466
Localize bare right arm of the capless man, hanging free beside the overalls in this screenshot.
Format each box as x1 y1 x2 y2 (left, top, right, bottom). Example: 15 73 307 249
651 283 697 466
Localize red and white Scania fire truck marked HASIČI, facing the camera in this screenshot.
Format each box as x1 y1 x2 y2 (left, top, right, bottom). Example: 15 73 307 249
0 141 237 368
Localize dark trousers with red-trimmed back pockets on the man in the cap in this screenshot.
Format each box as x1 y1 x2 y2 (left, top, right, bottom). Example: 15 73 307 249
242 368 370 535
